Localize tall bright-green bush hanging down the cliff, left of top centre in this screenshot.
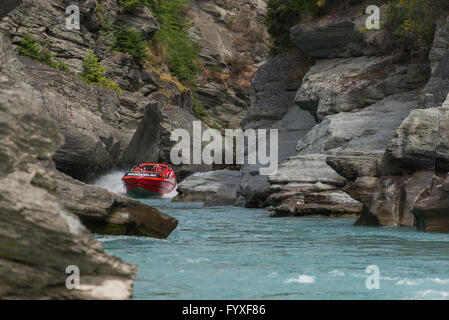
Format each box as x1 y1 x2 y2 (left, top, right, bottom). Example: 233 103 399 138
150 0 201 83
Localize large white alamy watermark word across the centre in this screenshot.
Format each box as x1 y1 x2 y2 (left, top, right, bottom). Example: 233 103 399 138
170 121 279 175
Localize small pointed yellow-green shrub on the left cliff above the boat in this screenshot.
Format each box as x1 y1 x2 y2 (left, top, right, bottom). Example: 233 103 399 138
81 50 122 94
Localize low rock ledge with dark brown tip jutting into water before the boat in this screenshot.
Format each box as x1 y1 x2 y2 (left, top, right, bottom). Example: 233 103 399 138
56 173 178 239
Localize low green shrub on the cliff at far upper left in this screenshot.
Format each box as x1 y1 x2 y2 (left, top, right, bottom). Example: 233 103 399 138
17 33 70 73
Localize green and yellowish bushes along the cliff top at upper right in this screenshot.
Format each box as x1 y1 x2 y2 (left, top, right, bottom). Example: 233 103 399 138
265 0 449 54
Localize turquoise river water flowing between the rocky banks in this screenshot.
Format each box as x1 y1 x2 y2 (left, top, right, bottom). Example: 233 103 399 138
96 174 449 299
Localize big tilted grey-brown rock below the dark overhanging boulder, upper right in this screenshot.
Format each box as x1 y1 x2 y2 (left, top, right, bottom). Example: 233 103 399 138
295 56 428 120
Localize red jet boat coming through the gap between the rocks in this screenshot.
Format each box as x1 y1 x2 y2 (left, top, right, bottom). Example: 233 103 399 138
122 163 176 196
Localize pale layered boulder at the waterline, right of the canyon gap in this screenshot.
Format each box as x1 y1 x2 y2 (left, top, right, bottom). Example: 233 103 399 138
266 154 362 217
